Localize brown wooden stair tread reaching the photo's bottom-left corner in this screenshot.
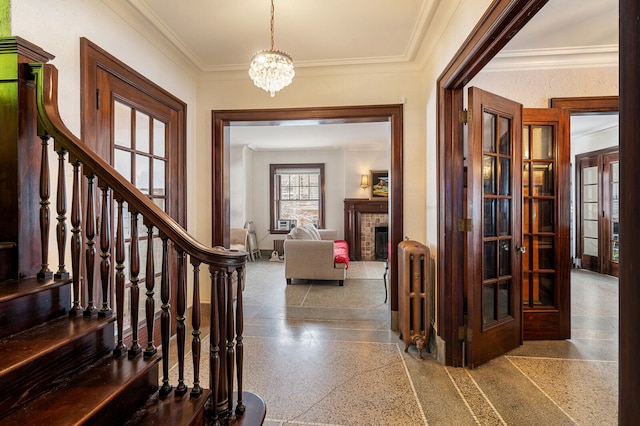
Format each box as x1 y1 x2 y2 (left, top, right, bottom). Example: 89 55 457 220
0 351 161 426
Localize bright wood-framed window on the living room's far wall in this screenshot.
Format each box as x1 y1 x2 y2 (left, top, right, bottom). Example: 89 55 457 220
270 164 324 234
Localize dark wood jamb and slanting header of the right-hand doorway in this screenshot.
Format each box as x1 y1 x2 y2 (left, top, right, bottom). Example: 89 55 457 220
436 0 547 366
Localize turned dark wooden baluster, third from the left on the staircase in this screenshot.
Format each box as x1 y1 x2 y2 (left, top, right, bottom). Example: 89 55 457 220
69 160 82 317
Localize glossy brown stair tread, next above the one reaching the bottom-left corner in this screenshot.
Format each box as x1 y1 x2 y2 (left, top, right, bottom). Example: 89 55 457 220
0 317 115 376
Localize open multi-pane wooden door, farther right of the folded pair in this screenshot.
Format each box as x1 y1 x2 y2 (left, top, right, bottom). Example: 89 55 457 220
522 108 571 340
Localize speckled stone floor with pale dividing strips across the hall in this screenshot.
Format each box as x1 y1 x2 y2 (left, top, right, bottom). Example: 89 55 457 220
168 260 618 426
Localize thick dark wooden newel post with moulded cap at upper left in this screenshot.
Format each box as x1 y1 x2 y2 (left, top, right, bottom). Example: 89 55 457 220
0 37 53 279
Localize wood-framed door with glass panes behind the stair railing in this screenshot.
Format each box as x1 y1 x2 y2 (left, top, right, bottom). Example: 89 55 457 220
97 69 180 346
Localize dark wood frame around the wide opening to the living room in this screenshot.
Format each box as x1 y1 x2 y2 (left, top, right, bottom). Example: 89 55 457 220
211 104 404 311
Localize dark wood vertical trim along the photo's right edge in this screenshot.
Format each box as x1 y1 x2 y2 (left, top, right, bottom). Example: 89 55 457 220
618 0 640 425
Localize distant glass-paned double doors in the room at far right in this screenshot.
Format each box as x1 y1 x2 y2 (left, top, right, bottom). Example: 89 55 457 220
576 147 620 276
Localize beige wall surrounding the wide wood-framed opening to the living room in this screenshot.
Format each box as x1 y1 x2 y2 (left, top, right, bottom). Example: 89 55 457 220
194 66 425 260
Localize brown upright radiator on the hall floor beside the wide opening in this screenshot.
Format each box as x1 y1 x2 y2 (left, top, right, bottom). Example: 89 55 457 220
398 240 431 359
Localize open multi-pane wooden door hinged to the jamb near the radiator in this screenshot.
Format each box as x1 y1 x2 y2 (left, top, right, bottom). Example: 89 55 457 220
465 87 522 368
